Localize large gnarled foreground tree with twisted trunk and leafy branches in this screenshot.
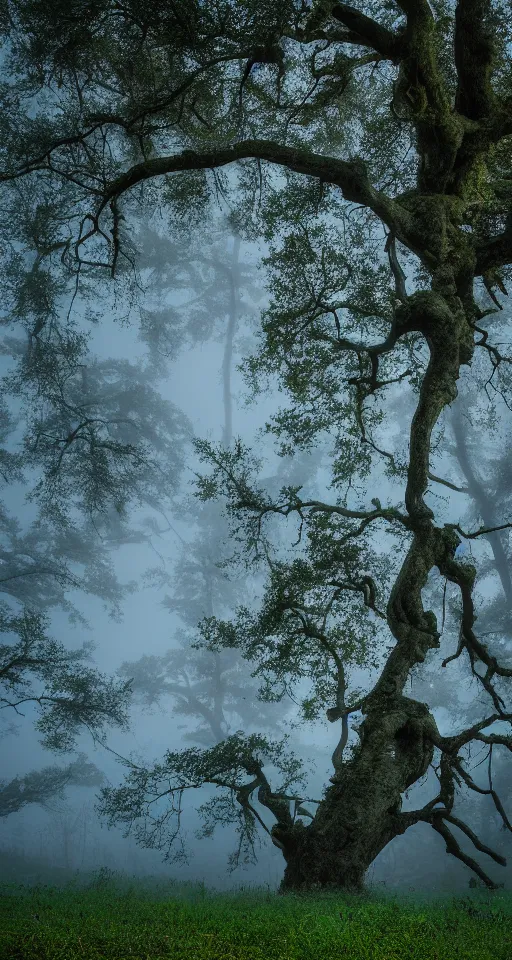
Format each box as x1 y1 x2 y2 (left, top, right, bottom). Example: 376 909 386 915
0 0 512 889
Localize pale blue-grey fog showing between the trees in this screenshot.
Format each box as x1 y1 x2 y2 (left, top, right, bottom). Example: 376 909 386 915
0 171 512 892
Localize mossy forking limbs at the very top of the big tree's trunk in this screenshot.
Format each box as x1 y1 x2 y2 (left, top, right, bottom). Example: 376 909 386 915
316 0 500 201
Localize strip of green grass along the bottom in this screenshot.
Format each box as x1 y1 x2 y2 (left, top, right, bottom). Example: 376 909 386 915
0 872 512 960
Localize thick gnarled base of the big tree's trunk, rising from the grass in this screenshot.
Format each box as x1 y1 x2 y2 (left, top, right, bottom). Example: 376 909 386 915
272 696 438 892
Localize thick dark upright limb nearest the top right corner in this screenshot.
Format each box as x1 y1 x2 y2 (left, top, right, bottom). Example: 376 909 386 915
454 0 495 120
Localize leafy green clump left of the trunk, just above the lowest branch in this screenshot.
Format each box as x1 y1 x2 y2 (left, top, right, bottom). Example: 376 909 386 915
192 547 386 726
